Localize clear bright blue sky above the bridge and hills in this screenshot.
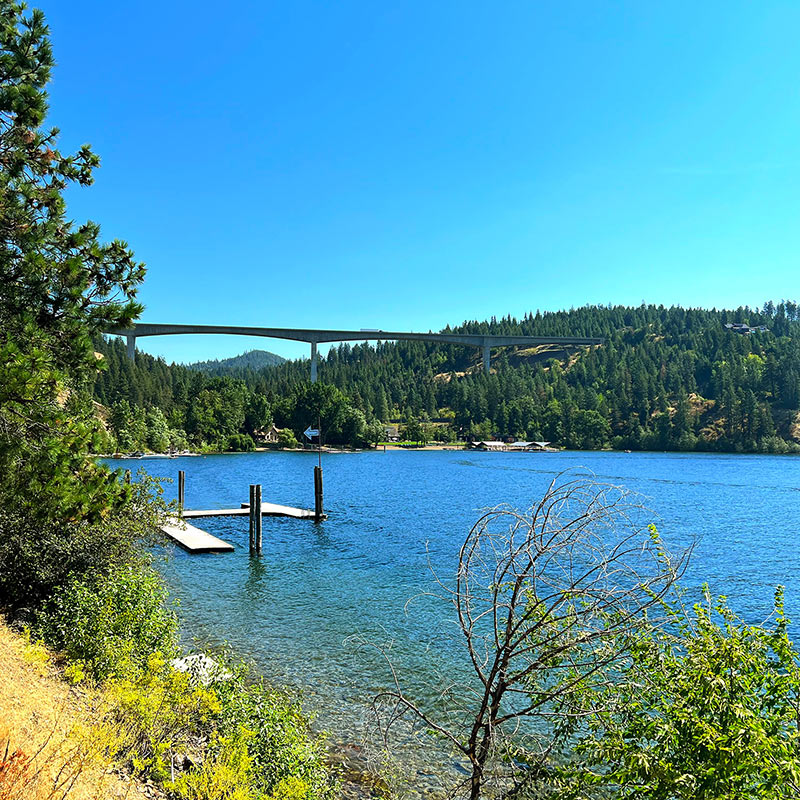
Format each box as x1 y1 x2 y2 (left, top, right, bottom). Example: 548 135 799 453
42 0 800 360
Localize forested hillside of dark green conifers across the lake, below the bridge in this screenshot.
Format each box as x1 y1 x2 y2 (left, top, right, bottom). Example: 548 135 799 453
90 302 800 452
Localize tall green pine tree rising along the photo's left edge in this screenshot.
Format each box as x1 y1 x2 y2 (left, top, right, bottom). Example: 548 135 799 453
0 0 144 520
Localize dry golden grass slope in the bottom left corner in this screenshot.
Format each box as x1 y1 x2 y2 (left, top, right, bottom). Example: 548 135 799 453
0 622 155 800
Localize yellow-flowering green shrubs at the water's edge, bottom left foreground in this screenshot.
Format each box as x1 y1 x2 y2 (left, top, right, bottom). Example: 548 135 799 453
109 653 339 800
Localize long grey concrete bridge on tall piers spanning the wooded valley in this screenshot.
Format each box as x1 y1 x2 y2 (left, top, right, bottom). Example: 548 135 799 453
106 322 603 383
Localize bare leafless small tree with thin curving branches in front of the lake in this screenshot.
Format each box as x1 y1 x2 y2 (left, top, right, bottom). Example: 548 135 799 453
375 473 689 800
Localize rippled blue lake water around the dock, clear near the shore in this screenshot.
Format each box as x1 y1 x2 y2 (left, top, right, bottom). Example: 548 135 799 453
109 451 800 768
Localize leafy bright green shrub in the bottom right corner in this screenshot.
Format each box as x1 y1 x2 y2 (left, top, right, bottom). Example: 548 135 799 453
562 589 800 800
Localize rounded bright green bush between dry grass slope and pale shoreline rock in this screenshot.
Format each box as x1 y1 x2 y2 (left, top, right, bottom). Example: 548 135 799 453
35 564 177 681
